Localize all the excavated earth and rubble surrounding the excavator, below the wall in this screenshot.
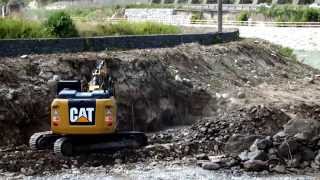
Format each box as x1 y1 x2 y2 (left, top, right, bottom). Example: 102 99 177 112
0 40 320 174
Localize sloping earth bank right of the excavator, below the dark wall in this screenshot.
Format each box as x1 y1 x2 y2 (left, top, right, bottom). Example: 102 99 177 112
106 40 315 131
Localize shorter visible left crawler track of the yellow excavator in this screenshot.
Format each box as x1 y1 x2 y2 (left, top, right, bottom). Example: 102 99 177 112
29 131 60 150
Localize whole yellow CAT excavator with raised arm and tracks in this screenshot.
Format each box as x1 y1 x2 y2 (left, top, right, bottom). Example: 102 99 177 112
29 61 147 156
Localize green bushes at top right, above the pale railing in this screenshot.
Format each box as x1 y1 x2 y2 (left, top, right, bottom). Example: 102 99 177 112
258 5 320 22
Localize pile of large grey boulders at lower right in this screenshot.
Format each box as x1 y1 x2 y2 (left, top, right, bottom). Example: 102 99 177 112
198 119 320 173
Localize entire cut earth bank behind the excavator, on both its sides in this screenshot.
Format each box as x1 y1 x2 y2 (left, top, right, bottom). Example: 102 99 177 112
0 40 311 144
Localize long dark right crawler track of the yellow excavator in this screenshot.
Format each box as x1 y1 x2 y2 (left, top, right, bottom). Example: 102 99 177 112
54 132 148 157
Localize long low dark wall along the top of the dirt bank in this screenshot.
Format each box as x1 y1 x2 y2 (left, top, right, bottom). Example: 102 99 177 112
0 30 239 57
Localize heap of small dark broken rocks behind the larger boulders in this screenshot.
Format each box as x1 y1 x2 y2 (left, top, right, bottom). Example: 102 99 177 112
192 105 290 149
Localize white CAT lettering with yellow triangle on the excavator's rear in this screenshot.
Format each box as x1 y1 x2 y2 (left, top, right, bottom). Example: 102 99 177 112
69 107 94 124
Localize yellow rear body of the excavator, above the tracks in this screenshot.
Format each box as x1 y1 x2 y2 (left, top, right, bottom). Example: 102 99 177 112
51 96 117 135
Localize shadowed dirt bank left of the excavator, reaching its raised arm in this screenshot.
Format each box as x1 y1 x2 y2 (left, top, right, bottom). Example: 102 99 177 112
0 56 95 144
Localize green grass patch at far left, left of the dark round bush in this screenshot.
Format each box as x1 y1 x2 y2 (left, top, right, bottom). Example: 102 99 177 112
0 18 52 39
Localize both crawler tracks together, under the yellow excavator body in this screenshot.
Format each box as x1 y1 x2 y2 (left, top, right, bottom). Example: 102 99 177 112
29 131 147 156
